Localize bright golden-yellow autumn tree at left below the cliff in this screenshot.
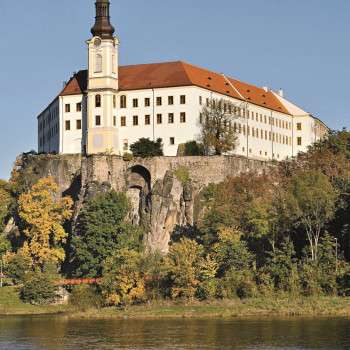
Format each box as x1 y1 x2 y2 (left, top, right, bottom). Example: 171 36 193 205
18 177 73 267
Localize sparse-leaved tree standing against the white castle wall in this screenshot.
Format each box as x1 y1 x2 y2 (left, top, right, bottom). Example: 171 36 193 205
200 99 237 155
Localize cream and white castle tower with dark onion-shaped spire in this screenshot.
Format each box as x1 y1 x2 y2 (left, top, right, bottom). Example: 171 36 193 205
85 0 119 154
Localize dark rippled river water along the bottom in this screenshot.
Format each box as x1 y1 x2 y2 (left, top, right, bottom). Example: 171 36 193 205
0 317 350 350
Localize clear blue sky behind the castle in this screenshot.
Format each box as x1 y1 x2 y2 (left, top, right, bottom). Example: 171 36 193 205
0 0 350 178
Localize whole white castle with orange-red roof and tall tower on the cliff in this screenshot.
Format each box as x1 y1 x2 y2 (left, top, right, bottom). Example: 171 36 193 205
38 0 328 160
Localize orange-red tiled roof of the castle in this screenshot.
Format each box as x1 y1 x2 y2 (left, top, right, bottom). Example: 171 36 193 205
60 61 290 114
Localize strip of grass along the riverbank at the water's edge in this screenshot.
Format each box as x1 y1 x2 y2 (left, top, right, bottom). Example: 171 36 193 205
0 287 350 319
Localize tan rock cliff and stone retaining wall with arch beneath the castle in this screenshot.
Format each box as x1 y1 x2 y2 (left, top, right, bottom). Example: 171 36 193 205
18 155 271 254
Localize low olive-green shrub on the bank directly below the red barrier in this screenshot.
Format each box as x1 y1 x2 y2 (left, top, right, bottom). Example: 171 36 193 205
69 286 103 311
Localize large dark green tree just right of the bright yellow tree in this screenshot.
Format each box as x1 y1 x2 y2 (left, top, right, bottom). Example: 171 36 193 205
71 191 142 277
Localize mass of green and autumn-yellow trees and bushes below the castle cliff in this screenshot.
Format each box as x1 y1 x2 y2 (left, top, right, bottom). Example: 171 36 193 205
0 130 350 316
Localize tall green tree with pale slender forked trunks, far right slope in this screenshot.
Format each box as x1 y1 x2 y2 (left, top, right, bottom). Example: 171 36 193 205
286 170 337 261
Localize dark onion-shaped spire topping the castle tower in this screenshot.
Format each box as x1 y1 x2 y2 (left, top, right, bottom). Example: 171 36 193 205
91 0 115 39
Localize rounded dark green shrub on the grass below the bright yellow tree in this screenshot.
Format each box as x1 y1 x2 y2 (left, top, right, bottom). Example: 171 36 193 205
21 270 58 305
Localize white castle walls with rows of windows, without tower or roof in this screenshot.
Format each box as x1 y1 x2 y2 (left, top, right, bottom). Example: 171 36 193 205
38 86 326 160
